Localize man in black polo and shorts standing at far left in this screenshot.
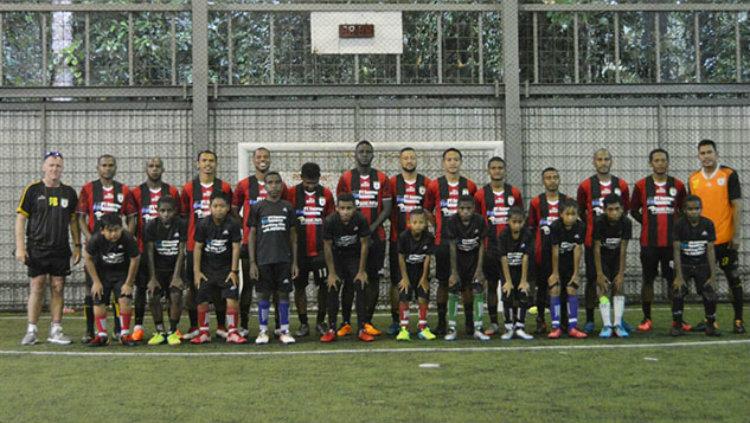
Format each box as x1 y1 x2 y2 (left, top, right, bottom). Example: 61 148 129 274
15 151 81 345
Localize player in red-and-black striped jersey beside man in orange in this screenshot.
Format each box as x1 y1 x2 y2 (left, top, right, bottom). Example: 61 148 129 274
630 148 692 332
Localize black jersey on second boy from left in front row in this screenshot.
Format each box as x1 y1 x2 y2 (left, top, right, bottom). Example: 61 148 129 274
143 217 187 271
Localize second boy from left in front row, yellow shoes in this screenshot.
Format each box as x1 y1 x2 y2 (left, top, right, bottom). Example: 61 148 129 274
144 196 187 345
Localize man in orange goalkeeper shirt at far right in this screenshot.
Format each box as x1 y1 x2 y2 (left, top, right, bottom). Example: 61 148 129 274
688 139 745 333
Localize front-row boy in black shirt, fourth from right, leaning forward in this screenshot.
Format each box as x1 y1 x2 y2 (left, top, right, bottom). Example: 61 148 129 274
497 206 534 341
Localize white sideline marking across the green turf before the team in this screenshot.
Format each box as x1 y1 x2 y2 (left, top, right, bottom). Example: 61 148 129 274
0 339 750 357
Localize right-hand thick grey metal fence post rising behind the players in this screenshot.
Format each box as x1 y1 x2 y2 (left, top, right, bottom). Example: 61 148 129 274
502 0 524 187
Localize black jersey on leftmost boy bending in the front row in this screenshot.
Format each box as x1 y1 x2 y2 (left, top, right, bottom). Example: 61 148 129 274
86 231 139 280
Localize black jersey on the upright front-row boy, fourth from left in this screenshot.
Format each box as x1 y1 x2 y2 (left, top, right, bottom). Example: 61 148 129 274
247 199 297 266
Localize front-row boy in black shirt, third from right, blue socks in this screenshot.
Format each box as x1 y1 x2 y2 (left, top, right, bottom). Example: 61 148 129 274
547 199 588 339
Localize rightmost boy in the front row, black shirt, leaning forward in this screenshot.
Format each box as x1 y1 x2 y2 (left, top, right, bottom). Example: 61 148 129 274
670 195 721 336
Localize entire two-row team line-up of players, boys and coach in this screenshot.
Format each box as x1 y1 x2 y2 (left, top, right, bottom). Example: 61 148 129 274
16 140 745 346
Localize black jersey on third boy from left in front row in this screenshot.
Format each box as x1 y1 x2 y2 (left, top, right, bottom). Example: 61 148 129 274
195 217 242 274
